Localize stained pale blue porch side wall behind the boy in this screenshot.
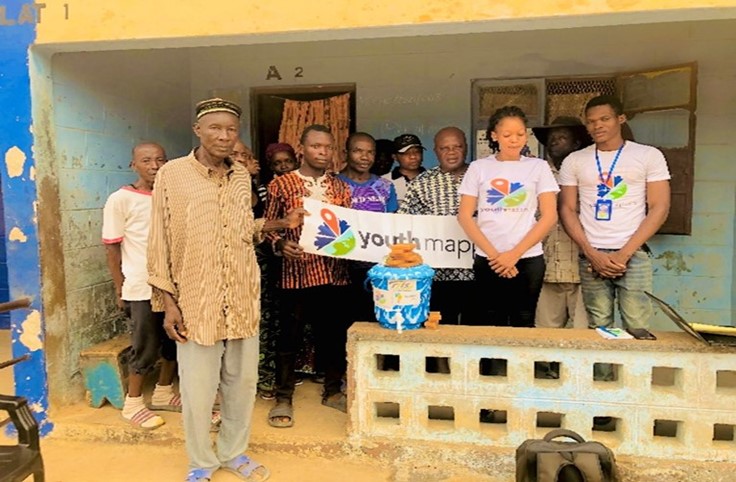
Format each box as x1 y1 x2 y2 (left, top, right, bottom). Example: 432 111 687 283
38 51 191 401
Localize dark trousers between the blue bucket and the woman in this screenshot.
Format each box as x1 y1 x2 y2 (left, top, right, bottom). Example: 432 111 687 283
429 281 477 325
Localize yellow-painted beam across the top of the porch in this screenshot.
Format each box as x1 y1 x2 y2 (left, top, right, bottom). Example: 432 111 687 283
37 0 736 44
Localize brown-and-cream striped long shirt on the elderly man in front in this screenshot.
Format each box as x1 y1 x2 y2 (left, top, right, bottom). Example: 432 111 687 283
148 151 264 346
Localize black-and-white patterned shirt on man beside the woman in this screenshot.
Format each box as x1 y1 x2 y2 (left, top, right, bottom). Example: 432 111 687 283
398 167 473 281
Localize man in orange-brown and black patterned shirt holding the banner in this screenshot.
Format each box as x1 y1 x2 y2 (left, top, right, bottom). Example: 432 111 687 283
266 125 351 428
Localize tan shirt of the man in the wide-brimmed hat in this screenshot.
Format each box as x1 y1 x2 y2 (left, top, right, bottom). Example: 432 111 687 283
542 168 580 283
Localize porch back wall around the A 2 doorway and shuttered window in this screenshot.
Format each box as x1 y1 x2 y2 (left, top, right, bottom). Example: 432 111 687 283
191 21 736 329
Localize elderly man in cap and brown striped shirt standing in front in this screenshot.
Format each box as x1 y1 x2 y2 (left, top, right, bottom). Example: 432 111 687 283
148 99 304 482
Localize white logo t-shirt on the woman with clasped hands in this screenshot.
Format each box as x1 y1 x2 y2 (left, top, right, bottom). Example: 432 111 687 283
459 156 560 258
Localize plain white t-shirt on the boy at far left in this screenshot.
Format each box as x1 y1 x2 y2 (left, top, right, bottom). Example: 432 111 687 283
102 186 151 301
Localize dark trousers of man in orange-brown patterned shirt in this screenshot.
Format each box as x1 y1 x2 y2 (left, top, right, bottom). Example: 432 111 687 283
276 285 352 401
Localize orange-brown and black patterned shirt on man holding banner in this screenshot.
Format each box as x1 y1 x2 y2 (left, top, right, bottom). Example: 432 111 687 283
266 170 351 289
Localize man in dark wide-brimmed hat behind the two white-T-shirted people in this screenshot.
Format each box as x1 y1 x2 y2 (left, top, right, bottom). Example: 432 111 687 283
532 116 593 342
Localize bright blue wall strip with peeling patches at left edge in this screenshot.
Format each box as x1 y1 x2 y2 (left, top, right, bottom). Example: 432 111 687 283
0 0 52 434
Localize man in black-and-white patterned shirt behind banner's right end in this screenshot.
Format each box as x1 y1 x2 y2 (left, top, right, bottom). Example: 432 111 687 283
398 127 477 324
